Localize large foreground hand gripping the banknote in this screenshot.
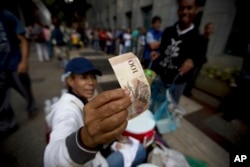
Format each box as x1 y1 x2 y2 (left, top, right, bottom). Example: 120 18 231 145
81 89 131 148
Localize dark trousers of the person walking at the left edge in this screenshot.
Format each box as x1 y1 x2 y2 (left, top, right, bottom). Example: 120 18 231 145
0 71 36 132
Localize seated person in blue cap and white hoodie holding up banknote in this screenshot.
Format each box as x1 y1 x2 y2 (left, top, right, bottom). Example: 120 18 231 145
44 57 146 167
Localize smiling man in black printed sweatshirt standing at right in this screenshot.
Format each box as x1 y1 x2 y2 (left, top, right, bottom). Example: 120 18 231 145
151 0 202 103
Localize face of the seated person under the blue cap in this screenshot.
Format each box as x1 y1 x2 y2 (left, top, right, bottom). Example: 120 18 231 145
68 73 97 99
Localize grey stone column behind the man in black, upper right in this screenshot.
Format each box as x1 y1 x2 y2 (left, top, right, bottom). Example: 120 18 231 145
200 0 236 57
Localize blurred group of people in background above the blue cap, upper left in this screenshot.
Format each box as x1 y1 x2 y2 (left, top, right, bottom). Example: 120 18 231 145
25 17 83 67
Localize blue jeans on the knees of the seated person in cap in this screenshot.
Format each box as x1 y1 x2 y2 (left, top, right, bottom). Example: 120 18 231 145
106 144 146 167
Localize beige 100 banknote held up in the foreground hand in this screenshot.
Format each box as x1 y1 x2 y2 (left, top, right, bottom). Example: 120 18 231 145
109 52 151 119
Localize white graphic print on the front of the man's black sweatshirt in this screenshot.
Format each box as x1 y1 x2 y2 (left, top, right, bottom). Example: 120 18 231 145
160 38 182 69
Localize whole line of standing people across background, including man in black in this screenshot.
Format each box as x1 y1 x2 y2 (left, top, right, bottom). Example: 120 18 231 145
26 10 213 105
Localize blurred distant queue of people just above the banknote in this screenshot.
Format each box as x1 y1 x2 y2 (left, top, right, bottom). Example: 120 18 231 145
85 27 146 56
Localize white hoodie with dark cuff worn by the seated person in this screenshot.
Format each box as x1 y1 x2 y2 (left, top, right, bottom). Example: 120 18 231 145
44 93 108 167
